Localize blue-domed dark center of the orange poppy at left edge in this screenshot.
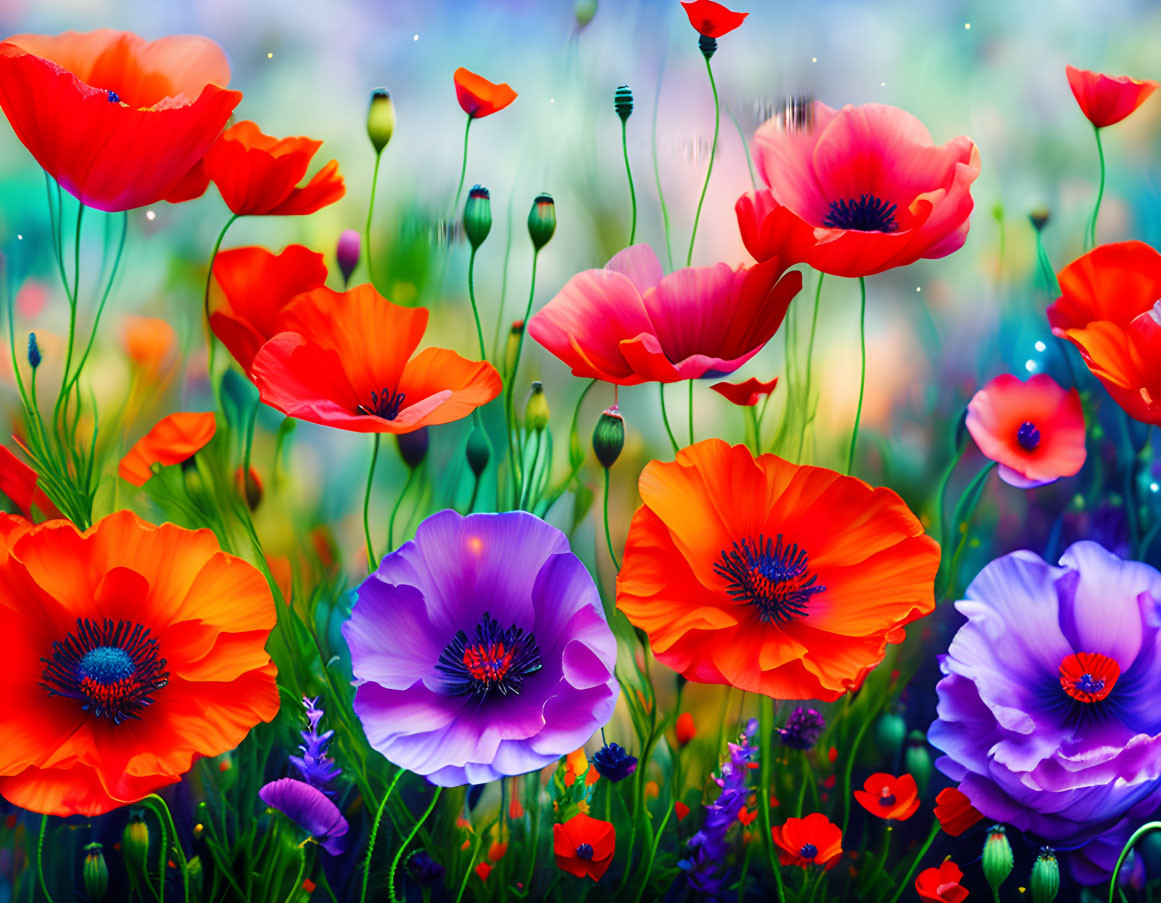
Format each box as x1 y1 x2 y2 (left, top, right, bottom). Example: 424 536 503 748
41 617 170 724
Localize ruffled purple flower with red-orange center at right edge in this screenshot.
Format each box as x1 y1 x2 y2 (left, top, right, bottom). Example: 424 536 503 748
928 542 1161 883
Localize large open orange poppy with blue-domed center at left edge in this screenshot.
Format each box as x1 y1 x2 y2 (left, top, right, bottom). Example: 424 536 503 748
0 511 279 816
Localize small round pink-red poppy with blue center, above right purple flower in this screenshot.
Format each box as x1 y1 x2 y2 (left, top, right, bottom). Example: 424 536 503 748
967 374 1086 489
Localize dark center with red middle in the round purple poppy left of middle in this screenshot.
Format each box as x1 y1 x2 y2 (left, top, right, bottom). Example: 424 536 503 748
435 612 541 699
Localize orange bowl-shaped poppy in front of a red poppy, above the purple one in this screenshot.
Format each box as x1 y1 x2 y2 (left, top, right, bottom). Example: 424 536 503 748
250 286 500 433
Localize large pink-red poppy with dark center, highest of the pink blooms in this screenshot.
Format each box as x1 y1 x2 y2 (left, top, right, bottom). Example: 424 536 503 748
735 101 980 276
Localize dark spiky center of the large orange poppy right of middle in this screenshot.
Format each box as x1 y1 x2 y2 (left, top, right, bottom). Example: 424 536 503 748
714 535 827 623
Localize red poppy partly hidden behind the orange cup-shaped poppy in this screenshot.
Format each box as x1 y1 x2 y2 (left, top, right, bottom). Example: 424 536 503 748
209 245 326 371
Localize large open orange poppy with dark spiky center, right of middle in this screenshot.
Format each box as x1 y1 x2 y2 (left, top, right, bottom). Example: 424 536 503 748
616 439 939 701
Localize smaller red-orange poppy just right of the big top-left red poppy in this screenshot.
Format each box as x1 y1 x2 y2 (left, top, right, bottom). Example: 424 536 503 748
205 120 347 216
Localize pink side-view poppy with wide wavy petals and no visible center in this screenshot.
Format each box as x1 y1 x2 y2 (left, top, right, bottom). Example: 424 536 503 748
528 245 802 385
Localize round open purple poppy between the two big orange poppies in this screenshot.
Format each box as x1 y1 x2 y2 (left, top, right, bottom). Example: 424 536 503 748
342 511 620 787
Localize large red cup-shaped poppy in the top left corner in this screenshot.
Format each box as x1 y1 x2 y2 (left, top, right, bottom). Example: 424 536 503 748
0 28 241 211
